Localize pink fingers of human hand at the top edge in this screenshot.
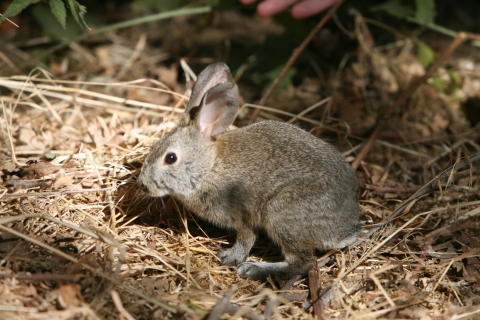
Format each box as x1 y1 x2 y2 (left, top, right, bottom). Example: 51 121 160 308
240 0 339 19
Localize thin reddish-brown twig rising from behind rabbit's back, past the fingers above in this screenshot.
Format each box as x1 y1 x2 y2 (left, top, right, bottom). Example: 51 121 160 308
250 0 343 123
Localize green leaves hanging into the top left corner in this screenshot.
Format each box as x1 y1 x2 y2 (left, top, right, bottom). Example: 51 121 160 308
0 0 89 29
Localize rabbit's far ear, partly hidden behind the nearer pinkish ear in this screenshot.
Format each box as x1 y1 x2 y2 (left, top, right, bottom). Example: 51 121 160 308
184 62 230 123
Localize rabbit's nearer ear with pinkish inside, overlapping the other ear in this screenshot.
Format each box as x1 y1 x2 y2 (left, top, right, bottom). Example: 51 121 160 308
195 82 238 137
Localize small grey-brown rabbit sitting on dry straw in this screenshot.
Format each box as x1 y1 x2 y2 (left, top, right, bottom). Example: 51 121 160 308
137 63 360 279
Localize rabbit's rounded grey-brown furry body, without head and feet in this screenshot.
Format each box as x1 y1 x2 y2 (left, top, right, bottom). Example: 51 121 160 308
200 121 360 251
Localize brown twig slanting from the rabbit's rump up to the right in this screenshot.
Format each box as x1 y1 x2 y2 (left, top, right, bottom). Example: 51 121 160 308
352 32 473 170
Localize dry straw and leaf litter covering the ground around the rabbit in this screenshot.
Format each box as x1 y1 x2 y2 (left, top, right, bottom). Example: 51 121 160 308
0 5 480 319
